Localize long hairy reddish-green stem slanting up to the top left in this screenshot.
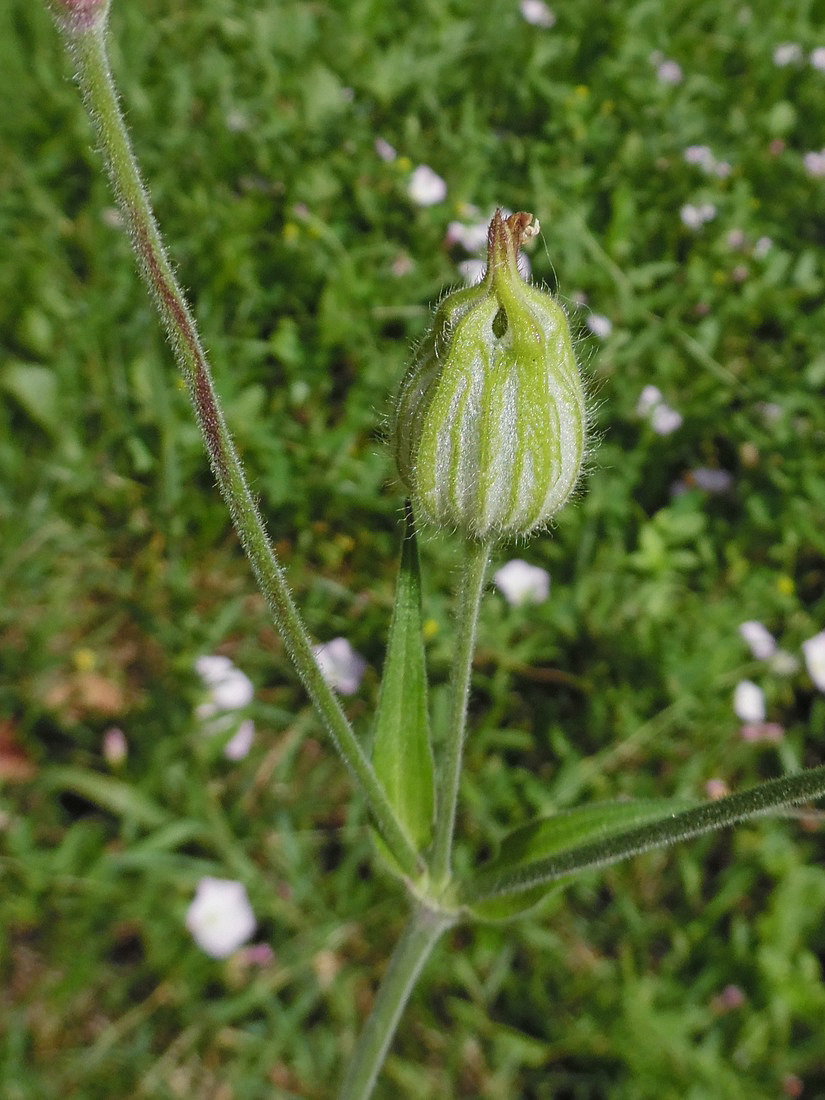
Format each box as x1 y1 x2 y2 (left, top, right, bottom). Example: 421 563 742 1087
62 17 422 876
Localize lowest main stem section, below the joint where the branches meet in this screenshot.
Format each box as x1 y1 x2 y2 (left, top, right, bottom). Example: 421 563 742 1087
339 906 454 1100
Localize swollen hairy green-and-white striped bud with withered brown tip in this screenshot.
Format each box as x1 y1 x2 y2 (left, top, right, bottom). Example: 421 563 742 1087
394 210 586 539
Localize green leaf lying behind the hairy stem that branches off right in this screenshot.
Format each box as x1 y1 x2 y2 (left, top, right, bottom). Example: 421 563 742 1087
469 800 686 921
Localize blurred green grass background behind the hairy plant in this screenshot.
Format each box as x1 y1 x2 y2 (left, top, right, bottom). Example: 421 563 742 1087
0 0 825 1100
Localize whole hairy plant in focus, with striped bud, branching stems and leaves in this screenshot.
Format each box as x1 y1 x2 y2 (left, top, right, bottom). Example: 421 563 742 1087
48 0 825 1100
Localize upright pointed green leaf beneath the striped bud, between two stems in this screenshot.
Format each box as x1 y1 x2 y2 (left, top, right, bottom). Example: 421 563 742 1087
373 506 435 871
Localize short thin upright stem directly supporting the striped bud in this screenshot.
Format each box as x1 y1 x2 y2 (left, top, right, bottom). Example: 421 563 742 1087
431 539 490 889
